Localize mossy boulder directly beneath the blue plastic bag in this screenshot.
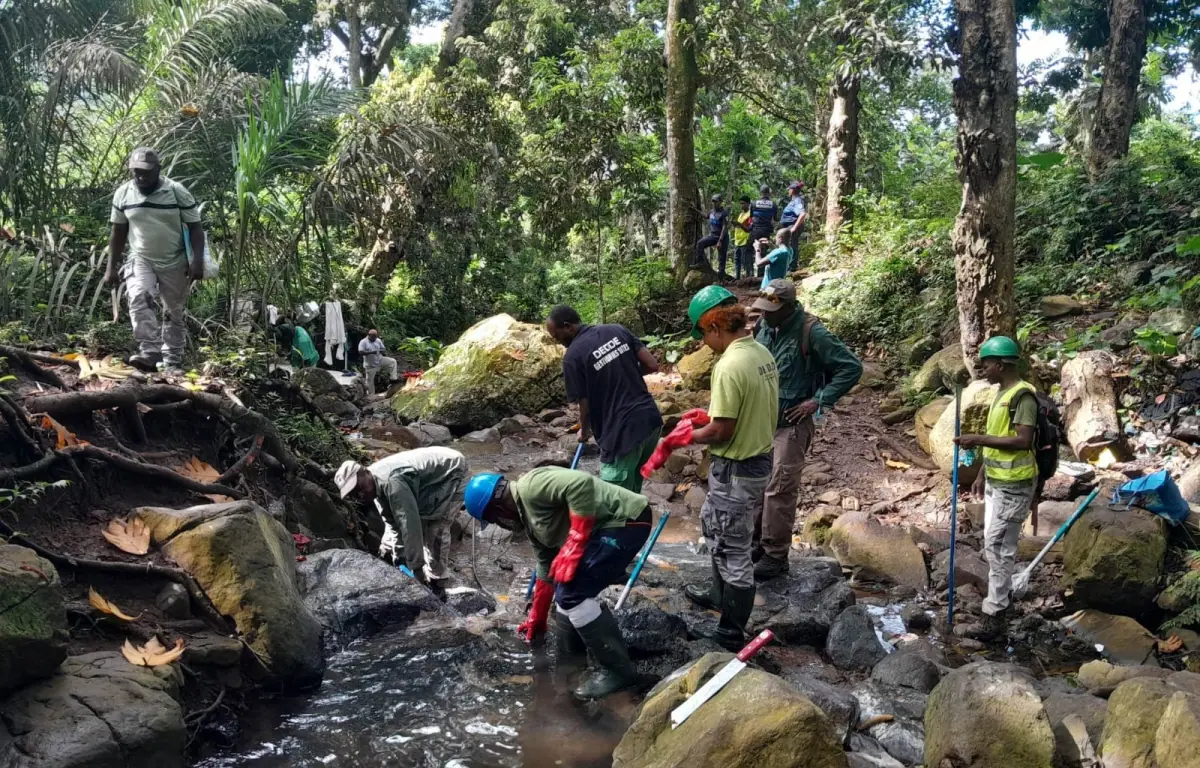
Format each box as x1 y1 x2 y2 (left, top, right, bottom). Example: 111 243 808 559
1062 505 1166 616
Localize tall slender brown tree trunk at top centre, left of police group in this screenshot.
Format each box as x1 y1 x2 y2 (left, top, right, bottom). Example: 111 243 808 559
666 0 701 280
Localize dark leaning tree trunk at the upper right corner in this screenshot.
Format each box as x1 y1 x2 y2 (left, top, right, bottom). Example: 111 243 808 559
1087 0 1146 178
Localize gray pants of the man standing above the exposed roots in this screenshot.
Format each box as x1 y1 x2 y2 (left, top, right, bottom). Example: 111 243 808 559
124 258 191 365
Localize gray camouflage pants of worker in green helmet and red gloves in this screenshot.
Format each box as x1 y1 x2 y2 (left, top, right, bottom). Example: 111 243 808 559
700 452 772 589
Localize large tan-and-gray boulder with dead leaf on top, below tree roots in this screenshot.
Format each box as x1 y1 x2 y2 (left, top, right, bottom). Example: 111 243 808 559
136 500 325 688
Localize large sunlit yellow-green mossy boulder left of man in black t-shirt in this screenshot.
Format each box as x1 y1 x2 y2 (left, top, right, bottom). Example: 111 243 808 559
392 314 566 431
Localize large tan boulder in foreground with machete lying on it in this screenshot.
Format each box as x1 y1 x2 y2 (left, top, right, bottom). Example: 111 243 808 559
612 653 846 768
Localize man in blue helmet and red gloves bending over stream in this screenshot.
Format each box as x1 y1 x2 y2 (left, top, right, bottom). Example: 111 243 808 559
463 467 652 698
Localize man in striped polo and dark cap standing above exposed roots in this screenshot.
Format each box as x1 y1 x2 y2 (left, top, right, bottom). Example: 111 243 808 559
104 148 205 371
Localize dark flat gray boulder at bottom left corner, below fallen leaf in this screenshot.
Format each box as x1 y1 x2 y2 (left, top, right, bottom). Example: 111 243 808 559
0 652 187 768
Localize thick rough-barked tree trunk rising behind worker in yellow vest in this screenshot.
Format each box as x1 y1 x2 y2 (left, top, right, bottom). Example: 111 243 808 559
952 0 1016 377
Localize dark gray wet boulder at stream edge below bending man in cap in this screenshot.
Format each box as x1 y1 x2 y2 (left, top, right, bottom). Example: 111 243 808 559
296 550 452 643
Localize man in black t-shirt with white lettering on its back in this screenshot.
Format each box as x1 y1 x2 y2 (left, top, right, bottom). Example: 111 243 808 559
546 304 662 493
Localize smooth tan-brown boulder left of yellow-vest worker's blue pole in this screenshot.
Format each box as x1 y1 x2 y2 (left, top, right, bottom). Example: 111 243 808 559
829 511 929 589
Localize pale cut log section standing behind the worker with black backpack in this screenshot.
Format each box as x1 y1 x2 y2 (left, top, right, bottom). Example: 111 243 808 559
1061 350 1121 462
